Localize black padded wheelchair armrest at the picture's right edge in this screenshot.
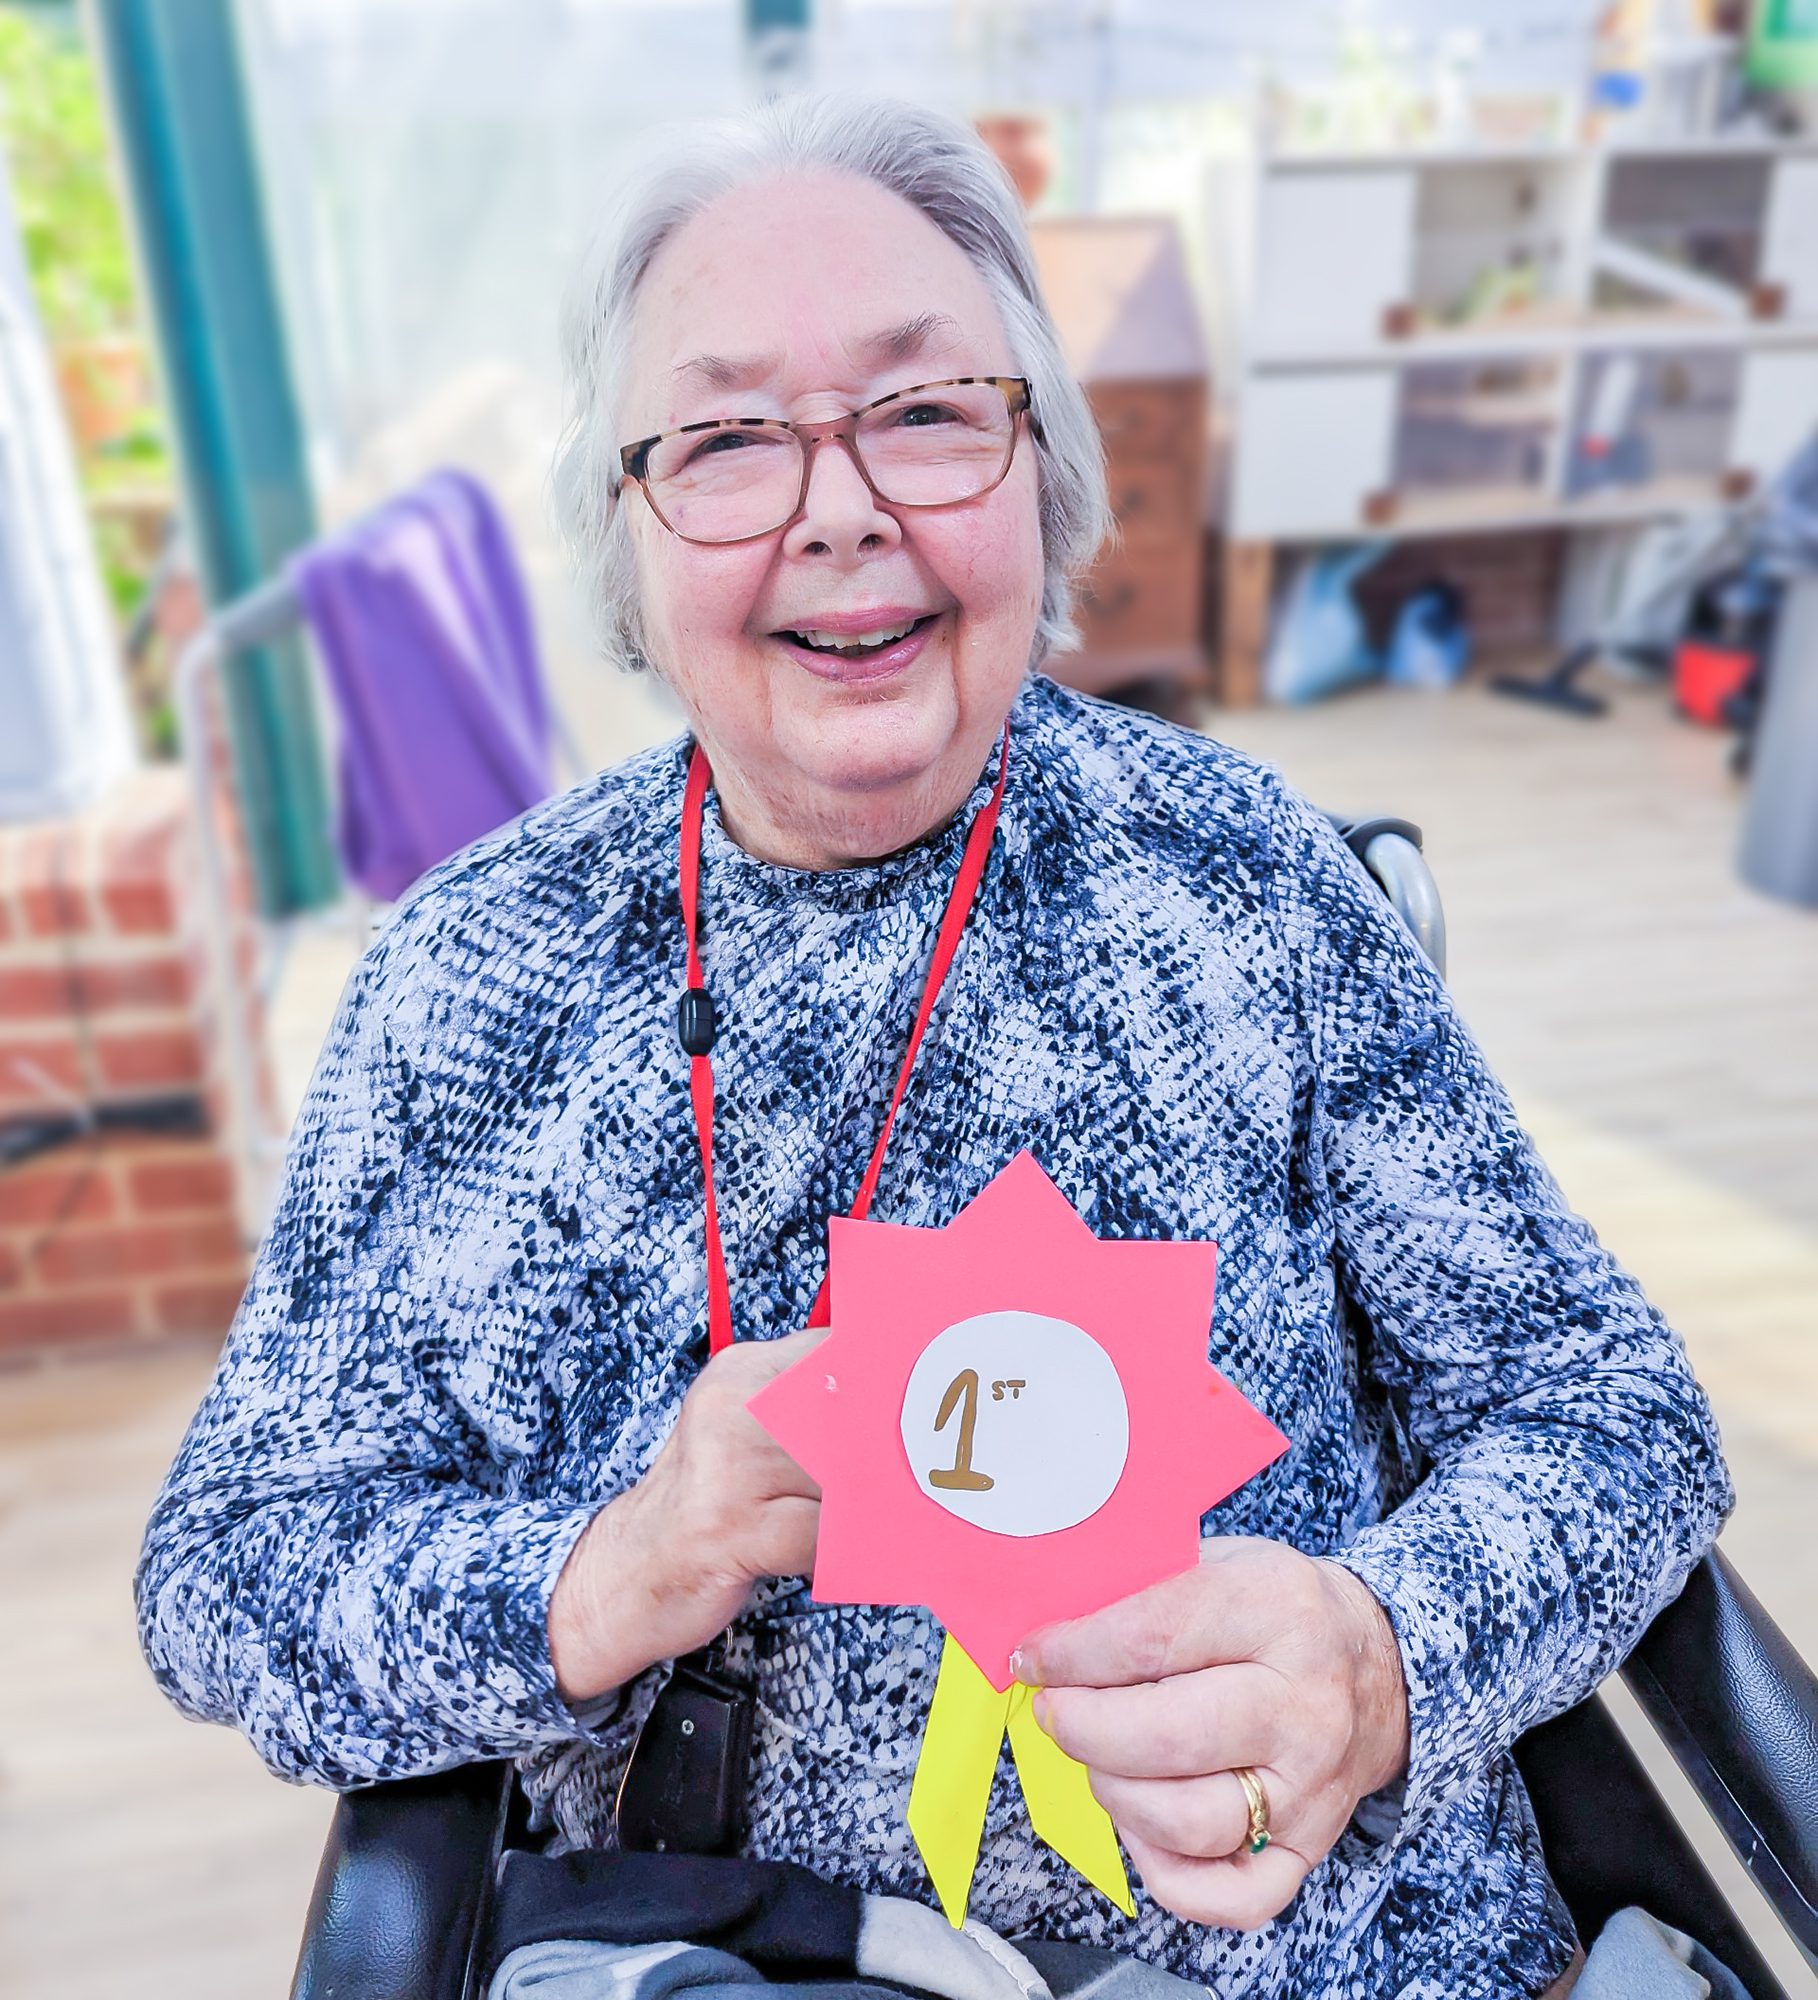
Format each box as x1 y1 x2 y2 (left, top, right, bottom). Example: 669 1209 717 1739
1622 1552 1818 1960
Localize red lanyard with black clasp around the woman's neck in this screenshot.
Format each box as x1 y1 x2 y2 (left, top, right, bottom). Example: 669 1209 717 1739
678 722 1010 1354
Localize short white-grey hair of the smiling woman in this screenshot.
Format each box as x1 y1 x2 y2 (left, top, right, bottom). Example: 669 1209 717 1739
554 96 1110 668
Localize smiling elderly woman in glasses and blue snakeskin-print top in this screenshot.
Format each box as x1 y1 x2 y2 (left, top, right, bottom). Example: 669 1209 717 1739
138 100 1730 1996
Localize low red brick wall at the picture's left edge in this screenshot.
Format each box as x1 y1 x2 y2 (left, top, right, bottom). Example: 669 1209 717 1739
0 768 262 1362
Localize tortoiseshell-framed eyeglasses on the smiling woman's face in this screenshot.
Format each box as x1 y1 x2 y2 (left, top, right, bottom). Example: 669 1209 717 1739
618 376 1036 542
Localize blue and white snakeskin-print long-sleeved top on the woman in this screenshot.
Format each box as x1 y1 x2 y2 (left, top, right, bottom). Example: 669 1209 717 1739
138 678 1730 1996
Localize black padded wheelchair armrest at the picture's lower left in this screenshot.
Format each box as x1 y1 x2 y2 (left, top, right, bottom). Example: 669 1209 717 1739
290 1764 516 2000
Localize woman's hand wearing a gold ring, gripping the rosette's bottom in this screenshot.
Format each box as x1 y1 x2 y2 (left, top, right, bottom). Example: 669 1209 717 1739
1016 1536 1408 1930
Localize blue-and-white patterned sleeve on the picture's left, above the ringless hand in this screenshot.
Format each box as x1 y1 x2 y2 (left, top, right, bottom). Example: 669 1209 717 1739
136 922 594 1786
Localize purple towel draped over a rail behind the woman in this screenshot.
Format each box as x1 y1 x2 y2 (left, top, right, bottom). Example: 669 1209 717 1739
290 472 552 902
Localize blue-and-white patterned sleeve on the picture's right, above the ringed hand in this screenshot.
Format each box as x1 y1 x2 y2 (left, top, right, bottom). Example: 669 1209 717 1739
1274 772 1732 1834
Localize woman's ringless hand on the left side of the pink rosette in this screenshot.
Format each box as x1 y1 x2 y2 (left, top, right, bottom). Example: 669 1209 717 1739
550 1326 826 1702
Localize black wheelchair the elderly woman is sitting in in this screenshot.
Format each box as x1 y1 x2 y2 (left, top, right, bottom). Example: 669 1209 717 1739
290 818 1818 2000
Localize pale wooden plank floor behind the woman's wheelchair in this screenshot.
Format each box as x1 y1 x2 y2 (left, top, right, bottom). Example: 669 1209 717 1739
0 668 1818 2000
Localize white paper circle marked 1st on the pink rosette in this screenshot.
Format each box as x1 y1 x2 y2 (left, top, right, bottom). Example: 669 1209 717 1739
902 1312 1130 1536
